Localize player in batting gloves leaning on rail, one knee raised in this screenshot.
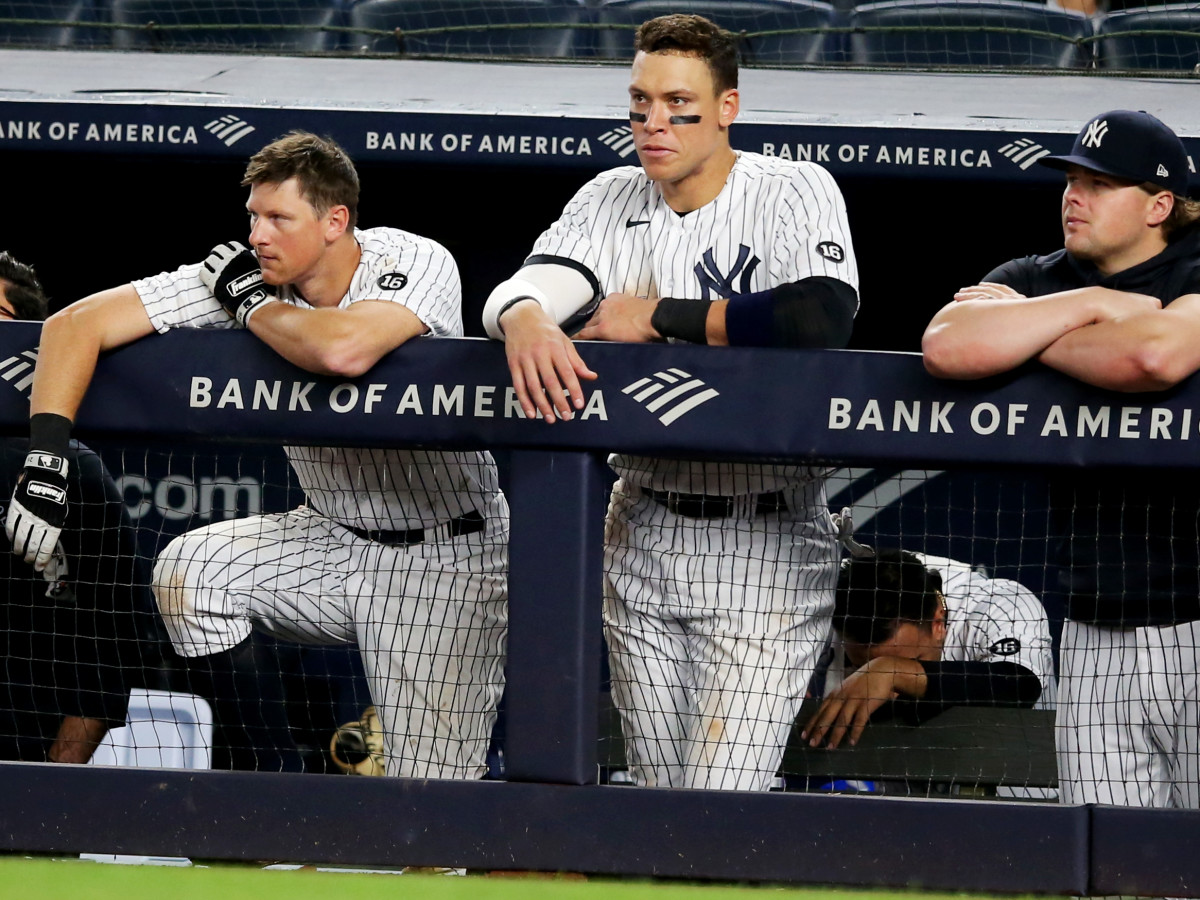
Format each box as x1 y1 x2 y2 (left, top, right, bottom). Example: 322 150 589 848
6 132 508 778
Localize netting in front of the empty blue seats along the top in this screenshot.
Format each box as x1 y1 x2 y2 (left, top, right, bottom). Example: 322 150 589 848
0 0 1200 72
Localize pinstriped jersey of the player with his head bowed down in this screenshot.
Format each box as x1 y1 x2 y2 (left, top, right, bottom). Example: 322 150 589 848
824 554 1054 708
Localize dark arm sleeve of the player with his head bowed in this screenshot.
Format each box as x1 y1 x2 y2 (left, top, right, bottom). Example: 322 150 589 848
894 661 1042 725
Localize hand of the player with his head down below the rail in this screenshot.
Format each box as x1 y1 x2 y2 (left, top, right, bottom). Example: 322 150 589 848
800 656 925 750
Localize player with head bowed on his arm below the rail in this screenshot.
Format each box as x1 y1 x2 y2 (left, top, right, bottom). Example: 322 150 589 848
802 545 1054 748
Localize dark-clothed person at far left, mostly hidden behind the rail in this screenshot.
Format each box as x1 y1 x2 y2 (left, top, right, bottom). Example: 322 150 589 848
0 252 163 763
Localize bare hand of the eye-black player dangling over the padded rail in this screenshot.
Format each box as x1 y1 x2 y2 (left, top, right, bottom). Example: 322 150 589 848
500 300 596 422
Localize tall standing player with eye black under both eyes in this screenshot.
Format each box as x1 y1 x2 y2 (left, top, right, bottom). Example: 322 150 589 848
484 16 858 790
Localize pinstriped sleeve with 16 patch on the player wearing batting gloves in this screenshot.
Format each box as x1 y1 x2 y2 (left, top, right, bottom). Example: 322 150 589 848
343 228 463 337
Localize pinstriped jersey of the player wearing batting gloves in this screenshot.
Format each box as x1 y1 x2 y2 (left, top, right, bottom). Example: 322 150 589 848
133 228 498 530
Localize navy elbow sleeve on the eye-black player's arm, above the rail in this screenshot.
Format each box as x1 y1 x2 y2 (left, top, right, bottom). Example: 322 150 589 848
725 276 858 348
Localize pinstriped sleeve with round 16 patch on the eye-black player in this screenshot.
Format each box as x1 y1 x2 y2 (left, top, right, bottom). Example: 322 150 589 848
774 162 858 290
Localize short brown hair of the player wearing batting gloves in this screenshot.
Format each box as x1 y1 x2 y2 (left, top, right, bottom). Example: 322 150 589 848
241 131 359 228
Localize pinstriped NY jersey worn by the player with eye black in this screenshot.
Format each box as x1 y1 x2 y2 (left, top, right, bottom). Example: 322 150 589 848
532 152 858 494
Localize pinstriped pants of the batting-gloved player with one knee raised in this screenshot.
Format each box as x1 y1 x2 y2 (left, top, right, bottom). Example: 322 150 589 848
154 496 508 778
